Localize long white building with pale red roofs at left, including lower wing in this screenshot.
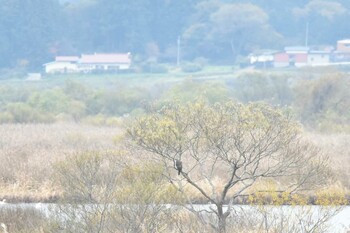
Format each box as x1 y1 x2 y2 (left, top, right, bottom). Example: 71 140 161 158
43 53 131 74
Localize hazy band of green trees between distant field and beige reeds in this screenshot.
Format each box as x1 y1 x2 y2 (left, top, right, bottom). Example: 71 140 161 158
0 72 350 132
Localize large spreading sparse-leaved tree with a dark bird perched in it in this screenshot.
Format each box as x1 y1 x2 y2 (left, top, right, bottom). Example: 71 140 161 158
128 102 326 232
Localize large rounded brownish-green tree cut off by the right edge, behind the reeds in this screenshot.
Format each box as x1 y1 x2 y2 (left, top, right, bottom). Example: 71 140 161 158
294 73 350 132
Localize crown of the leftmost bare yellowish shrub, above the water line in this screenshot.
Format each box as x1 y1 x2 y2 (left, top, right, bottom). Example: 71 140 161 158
54 151 122 202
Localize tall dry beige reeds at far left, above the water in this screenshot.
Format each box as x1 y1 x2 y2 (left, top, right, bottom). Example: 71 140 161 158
0 123 120 201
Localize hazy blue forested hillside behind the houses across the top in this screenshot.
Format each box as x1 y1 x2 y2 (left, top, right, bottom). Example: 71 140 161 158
0 0 350 70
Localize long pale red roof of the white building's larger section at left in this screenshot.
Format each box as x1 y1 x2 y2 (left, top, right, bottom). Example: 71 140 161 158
80 53 131 64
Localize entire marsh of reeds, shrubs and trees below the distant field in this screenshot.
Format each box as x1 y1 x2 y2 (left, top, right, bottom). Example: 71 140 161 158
0 70 350 232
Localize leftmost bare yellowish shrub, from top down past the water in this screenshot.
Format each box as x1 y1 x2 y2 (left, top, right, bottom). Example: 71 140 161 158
55 151 121 232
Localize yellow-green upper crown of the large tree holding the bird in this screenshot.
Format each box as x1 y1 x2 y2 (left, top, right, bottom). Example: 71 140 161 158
128 101 301 157
